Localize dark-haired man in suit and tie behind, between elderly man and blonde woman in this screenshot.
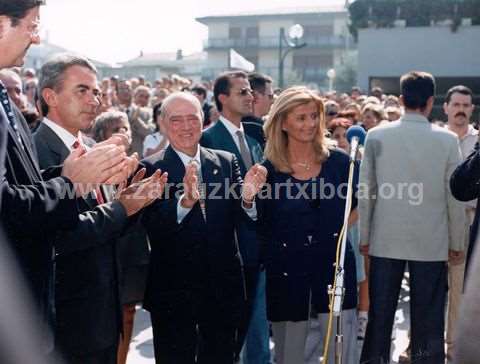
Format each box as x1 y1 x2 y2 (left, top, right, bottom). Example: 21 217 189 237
200 72 270 364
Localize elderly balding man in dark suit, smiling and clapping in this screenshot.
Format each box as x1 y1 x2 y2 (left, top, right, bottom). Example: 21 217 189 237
142 93 264 364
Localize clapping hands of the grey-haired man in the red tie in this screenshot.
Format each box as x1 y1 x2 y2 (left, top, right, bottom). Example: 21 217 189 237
117 168 168 216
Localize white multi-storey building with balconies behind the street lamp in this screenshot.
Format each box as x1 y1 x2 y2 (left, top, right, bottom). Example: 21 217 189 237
197 6 355 86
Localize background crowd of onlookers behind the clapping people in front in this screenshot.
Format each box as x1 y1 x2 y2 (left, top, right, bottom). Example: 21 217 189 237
0 59 476 362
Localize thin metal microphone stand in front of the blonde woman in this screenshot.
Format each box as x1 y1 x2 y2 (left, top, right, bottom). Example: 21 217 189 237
330 149 358 364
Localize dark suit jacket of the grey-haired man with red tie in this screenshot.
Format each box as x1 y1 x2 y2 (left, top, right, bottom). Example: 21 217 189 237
34 124 127 355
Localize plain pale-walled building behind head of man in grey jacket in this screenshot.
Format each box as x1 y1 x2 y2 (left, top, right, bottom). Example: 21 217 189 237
358 25 480 94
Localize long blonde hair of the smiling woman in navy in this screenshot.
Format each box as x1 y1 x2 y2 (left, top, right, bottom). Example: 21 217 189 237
263 86 329 173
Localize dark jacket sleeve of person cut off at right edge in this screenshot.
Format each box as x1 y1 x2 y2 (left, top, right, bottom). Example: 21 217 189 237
450 143 480 265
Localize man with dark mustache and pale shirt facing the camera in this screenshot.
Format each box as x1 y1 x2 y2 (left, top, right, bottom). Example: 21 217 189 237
443 85 478 358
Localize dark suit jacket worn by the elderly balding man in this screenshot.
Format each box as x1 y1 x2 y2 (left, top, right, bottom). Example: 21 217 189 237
142 146 248 325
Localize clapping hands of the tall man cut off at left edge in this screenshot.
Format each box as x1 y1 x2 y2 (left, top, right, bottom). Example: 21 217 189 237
62 144 128 197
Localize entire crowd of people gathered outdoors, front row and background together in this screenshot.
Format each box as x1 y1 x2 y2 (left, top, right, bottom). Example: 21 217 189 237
0 0 480 364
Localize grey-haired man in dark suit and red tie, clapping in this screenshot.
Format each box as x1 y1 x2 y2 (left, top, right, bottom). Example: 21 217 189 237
34 54 167 364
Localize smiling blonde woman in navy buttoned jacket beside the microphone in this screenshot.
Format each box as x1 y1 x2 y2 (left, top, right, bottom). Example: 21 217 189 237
243 87 358 364
